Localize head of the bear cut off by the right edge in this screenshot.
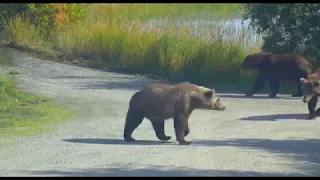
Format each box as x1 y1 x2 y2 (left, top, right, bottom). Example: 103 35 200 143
300 75 320 103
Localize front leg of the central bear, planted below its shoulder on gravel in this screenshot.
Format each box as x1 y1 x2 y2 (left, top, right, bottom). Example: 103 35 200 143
173 113 191 145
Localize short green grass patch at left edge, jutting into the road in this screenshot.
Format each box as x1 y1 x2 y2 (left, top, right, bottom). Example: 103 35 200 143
0 74 75 142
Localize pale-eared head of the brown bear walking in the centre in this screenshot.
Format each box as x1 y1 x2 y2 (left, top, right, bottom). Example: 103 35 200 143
198 86 226 111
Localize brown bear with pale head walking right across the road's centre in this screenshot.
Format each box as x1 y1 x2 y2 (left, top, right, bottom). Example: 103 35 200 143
123 82 225 145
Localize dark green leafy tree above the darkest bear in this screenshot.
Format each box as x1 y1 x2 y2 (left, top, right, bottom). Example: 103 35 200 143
243 3 320 58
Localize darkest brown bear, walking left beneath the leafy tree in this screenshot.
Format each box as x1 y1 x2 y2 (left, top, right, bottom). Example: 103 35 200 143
241 53 312 97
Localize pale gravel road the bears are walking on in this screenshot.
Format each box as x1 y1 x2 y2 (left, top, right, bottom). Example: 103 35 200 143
0 49 320 176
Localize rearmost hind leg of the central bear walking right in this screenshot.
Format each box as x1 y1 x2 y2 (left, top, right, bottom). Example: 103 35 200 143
123 109 144 142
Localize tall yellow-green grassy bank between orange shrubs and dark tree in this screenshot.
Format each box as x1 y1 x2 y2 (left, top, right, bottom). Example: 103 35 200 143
0 4 261 85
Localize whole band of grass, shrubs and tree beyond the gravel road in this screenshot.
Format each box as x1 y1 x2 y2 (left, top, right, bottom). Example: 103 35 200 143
2 3 320 86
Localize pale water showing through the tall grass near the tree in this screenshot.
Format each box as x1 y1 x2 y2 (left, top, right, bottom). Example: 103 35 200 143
142 18 262 46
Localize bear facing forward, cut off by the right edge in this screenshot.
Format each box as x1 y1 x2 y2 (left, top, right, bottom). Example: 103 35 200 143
300 69 320 119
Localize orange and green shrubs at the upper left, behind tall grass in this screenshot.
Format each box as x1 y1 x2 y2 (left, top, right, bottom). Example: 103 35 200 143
0 3 88 37
